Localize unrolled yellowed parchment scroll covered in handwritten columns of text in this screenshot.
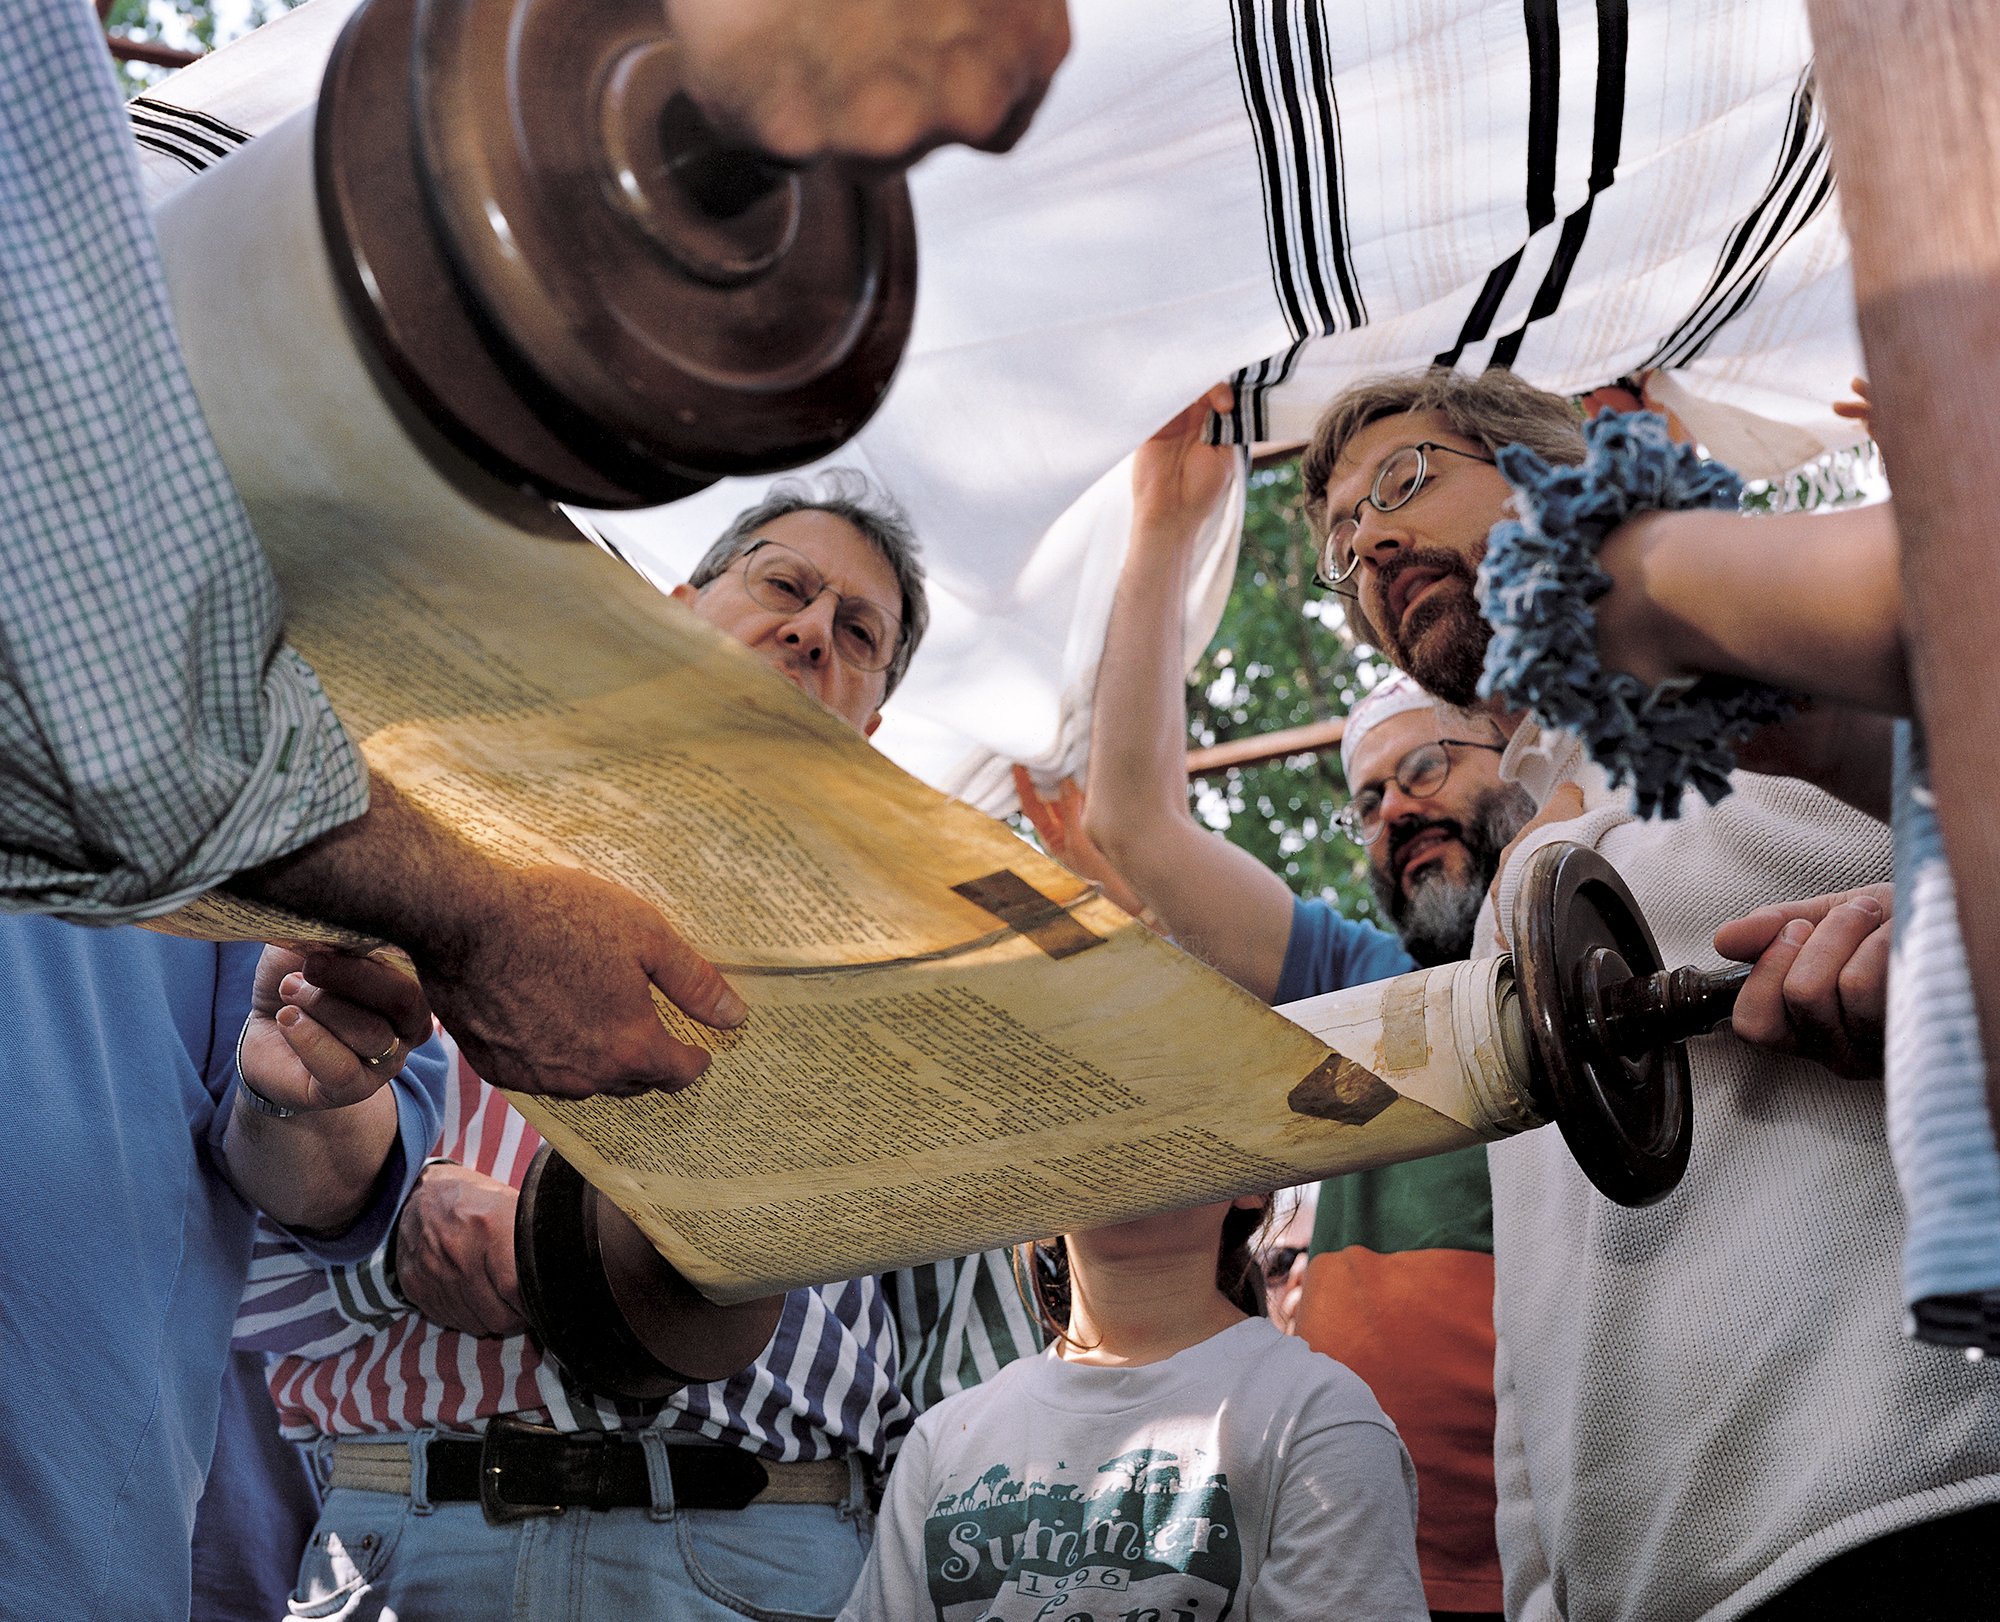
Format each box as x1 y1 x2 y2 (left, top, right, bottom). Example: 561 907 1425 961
148 114 1530 1300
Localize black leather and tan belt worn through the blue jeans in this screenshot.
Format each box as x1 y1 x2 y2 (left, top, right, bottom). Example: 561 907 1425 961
332 1414 852 1524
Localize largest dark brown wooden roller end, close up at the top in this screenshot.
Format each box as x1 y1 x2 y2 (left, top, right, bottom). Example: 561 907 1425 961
316 0 916 508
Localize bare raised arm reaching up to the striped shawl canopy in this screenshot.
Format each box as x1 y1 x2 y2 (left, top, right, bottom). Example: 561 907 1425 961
1084 400 1292 1002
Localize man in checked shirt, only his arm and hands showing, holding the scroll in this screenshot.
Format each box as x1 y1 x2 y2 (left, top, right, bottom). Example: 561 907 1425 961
0 0 1068 1096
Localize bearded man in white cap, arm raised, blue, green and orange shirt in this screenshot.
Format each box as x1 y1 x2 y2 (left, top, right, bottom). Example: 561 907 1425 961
1064 396 1534 1616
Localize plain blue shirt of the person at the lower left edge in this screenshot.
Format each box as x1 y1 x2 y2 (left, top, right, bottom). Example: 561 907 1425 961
0 916 446 1622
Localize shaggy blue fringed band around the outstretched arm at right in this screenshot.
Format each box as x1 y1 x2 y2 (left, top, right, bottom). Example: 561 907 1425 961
1478 412 1798 816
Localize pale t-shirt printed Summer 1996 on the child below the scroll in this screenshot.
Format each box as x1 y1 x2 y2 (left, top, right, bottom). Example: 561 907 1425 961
840 1318 1428 1622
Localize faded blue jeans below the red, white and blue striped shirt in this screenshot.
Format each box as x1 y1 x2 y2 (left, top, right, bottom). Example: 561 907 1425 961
290 1438 874 1622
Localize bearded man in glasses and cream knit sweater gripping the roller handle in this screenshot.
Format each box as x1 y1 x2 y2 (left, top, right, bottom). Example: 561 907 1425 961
1302 370 2000 1622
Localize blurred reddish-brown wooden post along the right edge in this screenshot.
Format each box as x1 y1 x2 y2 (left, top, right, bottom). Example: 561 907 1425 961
1810 0 2000 1118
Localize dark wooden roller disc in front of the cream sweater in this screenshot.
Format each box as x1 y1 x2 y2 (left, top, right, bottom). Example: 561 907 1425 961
1514 844 1696 1206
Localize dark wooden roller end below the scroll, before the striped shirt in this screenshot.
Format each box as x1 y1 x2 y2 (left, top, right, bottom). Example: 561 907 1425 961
514 1144 784 1402
